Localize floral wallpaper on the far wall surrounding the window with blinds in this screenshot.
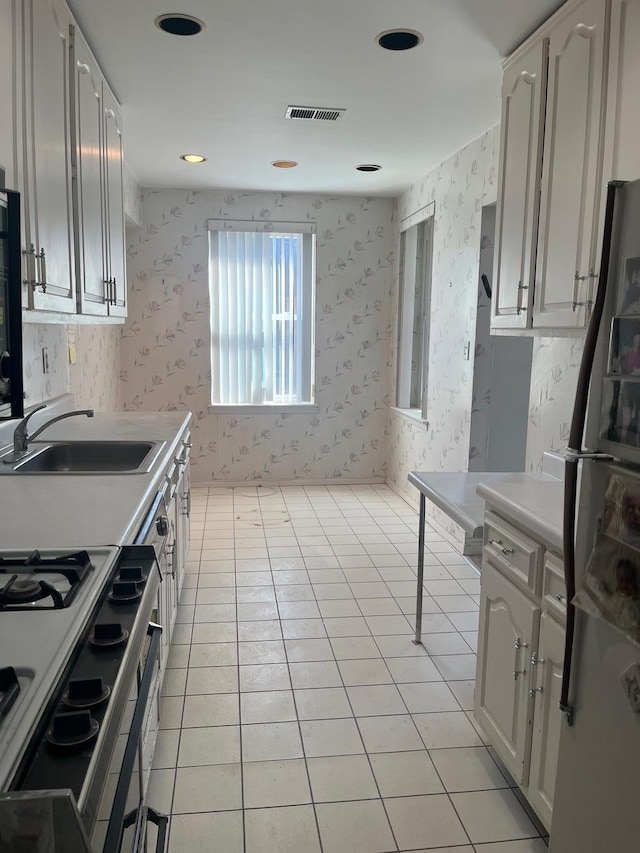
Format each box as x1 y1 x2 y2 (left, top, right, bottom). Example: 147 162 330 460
120 190 394 482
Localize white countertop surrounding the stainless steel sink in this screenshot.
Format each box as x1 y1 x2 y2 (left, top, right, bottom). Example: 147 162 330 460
0 409 191 549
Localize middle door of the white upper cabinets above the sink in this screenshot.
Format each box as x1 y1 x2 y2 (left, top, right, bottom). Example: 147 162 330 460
73 29 107 316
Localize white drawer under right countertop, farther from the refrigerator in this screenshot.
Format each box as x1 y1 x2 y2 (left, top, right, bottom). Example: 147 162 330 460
483 512 542 595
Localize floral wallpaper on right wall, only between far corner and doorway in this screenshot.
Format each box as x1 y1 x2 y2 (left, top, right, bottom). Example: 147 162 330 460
388 128 499 534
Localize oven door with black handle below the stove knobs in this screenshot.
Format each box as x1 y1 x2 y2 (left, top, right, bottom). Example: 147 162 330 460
91 622 168 853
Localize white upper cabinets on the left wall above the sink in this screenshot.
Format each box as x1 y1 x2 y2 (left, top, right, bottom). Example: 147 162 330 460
13 0 127 323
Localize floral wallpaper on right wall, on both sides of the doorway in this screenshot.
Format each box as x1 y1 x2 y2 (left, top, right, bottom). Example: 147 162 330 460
388 127 583 524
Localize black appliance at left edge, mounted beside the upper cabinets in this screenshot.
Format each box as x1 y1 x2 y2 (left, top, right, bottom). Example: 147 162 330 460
0 191 24 418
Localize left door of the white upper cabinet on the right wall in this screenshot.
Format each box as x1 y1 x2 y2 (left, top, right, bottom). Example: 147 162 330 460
491 39 549 329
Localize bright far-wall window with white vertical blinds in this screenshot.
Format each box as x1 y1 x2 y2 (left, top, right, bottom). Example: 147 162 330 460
209 220 315 408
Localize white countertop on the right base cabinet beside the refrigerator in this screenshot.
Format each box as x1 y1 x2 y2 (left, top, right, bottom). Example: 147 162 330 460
477 474 564 553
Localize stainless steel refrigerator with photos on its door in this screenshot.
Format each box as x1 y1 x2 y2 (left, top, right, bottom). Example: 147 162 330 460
550 181 640 853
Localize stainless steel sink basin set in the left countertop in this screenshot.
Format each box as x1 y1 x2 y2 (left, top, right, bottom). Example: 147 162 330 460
11 441 164 474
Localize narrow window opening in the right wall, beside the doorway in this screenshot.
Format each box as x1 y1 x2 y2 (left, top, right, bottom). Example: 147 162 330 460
396 216 433 418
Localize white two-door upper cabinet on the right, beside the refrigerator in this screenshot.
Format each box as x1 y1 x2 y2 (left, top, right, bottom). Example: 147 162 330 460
491 0 612 334
